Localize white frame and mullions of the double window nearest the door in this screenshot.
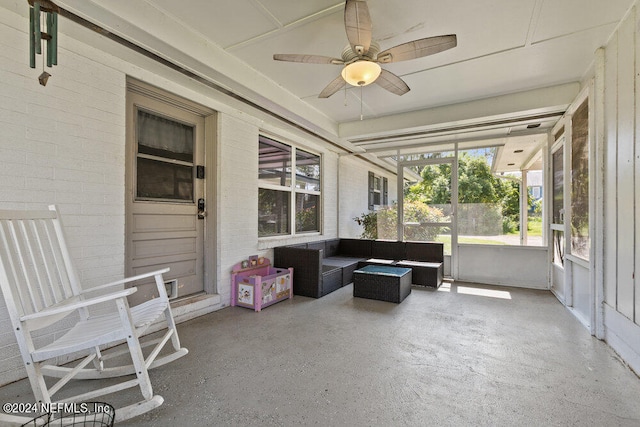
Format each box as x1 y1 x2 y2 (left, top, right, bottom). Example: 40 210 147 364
258 132 324 240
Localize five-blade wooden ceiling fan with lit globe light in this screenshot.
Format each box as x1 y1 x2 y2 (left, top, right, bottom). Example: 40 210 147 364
273 0 457 98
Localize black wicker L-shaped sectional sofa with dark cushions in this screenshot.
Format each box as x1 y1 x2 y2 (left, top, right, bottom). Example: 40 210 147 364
273 239 444 298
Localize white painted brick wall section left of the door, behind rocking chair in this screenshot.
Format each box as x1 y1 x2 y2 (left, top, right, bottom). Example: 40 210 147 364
0 14 125 384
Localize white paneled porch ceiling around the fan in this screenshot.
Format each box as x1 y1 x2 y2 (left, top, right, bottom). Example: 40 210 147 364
12 0 633 172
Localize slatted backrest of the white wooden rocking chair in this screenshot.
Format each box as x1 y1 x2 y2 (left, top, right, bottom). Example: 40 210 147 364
0 210 79 320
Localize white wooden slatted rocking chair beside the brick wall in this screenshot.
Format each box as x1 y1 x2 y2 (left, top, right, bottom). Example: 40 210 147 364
0 206 188 424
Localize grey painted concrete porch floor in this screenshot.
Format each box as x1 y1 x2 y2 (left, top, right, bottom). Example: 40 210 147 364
0 283 640 426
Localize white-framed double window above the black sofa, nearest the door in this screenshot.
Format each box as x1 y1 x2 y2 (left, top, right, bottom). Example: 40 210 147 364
258 136 322 237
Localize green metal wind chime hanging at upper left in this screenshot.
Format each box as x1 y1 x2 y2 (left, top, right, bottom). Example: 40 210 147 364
28 0 59 86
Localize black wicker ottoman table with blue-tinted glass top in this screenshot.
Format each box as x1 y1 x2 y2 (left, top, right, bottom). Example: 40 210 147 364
353 265 411 303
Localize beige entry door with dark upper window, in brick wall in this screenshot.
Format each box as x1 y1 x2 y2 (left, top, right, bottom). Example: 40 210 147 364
126 89 205 301
